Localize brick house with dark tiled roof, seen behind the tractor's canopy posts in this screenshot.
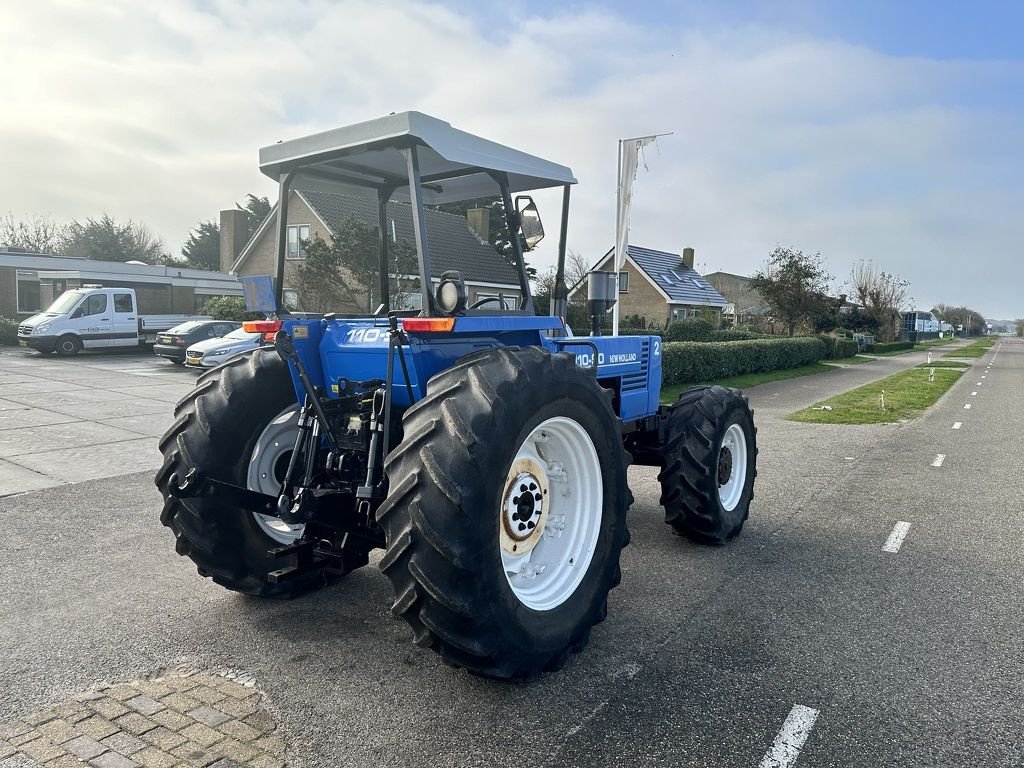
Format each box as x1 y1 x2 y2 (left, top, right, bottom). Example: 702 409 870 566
220 190 521 312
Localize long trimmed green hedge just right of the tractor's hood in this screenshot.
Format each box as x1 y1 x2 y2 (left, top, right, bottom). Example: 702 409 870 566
662 337 826 384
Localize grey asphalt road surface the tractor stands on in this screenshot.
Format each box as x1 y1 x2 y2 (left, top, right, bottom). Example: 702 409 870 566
0 342 1024 768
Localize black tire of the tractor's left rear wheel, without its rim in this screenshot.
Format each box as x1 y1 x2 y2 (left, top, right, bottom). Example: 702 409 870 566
155 349 344 597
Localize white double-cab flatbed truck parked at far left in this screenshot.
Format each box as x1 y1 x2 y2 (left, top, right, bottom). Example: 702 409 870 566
17 286 212 356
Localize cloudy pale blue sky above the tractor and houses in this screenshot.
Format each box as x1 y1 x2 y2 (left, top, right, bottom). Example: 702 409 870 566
0 0 1024 318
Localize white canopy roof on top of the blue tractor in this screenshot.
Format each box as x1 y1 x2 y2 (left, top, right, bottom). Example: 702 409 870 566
259 112 575 204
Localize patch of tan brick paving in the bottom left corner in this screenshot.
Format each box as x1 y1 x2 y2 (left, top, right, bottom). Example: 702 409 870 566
0 670 288 768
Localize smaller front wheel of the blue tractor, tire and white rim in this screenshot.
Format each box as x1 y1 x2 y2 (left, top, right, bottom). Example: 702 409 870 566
657 386 758 545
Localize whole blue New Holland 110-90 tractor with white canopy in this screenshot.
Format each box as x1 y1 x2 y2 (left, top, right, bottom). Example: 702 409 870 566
156 112 757 680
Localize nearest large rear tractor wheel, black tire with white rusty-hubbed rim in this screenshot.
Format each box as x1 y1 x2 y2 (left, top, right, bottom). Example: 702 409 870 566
377 347 633 680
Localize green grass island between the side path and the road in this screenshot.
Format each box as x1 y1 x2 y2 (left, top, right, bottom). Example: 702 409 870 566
786 368 964 424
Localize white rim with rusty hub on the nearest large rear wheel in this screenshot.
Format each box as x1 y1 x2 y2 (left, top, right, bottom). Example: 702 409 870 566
498 417 604 610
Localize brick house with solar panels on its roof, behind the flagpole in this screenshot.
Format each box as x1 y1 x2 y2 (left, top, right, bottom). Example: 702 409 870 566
581 245 727 328
